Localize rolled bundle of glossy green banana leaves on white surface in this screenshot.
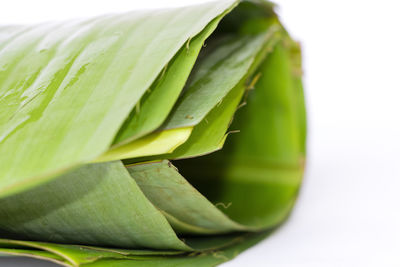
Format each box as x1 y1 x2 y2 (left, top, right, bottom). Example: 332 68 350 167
0 0 306 267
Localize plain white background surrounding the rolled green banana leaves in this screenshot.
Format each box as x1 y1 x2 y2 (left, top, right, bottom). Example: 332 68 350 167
0 0 400 267
